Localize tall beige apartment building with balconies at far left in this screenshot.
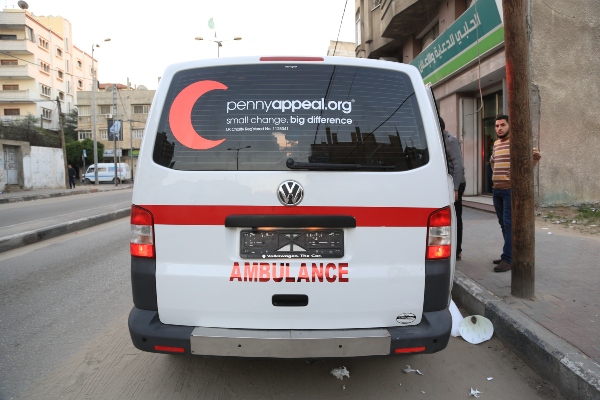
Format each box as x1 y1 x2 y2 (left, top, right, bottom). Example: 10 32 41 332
0 9 97 130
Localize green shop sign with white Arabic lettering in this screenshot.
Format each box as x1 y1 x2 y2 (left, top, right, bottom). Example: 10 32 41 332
411 0 504 84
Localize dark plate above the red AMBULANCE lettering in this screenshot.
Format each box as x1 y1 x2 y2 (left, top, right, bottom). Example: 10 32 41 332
240 229 344 259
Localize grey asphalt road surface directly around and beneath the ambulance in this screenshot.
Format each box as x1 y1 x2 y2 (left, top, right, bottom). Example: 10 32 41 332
0 218 561 400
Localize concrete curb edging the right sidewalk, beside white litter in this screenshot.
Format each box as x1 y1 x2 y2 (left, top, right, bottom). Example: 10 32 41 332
452 271 600 400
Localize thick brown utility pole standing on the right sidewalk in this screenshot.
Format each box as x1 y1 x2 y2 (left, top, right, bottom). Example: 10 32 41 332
502 0 535 298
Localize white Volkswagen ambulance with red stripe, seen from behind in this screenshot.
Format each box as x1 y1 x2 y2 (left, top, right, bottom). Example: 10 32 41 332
129 57 455 358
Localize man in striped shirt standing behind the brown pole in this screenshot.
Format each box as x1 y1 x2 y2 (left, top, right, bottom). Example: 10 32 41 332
490 115 542 272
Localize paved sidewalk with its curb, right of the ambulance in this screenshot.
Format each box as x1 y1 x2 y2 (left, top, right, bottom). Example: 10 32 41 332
460 196 600 399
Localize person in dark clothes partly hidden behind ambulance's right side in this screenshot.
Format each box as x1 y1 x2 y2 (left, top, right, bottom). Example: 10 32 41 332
440 117 467 260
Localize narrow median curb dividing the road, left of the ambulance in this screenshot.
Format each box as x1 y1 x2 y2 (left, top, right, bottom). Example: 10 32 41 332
0 207 131 253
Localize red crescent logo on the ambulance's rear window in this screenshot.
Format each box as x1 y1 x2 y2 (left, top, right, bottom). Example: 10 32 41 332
169 81 227 150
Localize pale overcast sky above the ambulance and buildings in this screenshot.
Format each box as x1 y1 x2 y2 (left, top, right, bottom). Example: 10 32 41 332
12 0 355 90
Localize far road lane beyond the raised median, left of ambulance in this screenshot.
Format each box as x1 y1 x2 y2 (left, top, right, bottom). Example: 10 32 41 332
0 189 133 237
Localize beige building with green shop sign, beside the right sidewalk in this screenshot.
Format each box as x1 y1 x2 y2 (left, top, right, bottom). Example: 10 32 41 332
355 0 600 205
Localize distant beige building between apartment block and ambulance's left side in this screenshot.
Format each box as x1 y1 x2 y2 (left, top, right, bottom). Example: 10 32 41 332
76 84 156 173
